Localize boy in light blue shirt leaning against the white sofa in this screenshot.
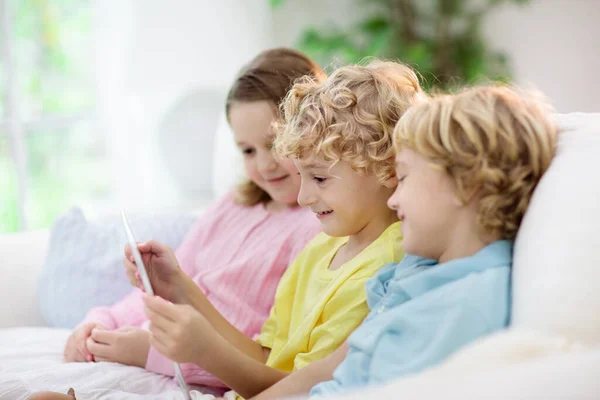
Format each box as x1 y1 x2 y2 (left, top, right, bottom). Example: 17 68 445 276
253 86 557 398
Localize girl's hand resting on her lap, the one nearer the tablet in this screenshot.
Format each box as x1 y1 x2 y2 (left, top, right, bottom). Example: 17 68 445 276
87 327 150 368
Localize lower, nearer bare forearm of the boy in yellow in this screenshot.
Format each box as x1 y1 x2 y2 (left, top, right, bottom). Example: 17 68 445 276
196 337 288 398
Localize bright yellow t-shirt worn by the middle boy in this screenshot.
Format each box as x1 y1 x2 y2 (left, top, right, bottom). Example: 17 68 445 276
258 222 403 372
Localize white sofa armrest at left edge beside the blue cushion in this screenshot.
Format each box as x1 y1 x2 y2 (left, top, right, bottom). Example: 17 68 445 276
0 230 50 328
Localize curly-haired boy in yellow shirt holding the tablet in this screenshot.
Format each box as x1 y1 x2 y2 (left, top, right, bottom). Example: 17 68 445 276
108 62 425 397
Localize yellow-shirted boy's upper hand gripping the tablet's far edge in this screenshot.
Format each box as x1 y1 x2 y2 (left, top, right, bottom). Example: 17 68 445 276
123 240 183 301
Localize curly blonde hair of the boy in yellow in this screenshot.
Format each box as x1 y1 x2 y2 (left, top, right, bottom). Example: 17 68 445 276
274 61 425 182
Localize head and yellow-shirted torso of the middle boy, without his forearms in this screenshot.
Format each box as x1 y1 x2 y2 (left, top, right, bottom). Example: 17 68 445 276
258 62 423 372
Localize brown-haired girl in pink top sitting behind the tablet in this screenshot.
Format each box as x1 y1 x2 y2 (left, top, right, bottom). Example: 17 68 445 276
64 49 323 387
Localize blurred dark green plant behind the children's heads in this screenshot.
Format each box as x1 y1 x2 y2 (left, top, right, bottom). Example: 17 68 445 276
269 0 529 90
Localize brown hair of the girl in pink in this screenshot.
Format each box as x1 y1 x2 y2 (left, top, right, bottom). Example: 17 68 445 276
225 48 325 206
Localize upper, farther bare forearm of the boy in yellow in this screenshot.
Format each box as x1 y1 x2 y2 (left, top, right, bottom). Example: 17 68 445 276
180 274 269 364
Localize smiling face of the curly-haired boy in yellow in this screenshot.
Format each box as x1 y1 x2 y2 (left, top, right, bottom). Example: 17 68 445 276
294 152 391 237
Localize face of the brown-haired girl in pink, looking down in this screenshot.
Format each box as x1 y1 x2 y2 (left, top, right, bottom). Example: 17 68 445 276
229 101 300 205
